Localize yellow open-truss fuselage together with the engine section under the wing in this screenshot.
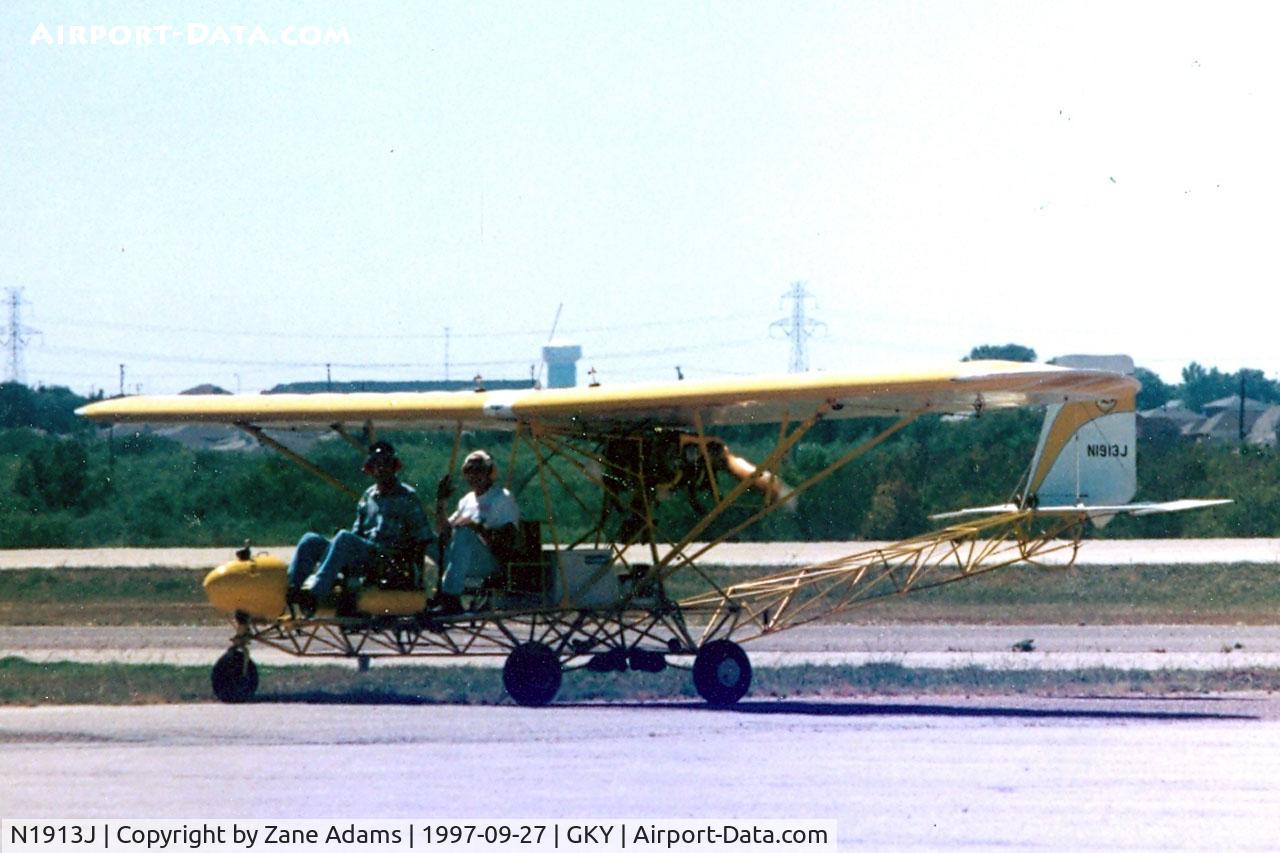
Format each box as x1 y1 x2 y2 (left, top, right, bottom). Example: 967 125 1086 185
225 406 1085 669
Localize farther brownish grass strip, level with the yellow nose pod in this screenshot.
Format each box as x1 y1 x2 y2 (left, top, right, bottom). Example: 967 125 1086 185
0 564 1280 625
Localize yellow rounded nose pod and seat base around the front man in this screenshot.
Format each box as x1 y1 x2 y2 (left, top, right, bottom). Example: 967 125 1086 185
205 553 426 619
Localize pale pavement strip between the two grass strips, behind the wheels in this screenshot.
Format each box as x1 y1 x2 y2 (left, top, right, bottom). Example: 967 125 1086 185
0 624 1280 670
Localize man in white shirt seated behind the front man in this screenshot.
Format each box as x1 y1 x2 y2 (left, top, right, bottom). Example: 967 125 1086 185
430 450 520 616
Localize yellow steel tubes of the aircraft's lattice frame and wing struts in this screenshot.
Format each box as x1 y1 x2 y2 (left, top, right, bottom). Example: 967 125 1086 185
233 409 1085 666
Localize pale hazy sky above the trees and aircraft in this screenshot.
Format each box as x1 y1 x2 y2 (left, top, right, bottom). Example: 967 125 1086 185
0 0 1280 393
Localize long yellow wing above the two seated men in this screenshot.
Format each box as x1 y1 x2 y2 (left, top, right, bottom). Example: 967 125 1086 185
78 361 1138 432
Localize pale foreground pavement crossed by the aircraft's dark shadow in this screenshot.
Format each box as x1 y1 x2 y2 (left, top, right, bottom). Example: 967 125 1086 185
0 695 1280 850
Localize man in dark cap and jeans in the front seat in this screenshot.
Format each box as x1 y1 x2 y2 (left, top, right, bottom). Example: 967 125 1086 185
287 442 435 616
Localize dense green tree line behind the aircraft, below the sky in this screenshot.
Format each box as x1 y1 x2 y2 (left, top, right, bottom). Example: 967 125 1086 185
0 345 1280 548
